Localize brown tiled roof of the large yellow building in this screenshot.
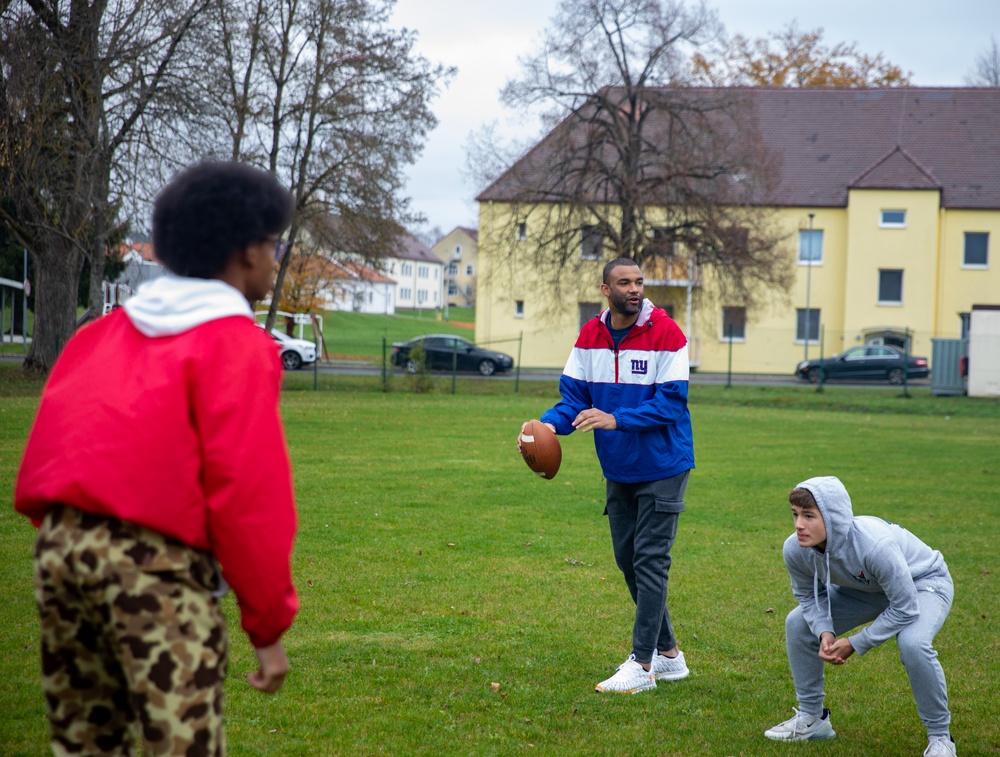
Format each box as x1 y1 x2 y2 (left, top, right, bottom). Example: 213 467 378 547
477 87 1000 209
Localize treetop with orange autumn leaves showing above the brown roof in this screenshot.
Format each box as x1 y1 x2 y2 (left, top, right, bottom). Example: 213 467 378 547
691 21 910 87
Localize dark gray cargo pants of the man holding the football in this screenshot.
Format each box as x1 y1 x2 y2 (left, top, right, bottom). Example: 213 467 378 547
604 471 689 663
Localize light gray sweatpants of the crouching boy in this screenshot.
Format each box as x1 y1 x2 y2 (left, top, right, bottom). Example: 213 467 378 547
785 577 955 736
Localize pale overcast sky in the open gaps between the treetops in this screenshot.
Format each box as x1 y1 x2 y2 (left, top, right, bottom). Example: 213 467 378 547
393 0 1000 239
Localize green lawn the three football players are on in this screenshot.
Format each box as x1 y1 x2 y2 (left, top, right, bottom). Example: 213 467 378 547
0 364 1000 757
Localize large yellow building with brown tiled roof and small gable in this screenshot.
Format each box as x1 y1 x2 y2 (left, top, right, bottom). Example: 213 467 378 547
476 88 1000 375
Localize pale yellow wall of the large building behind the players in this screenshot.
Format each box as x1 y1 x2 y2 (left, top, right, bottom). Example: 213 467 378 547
476 195 1000 375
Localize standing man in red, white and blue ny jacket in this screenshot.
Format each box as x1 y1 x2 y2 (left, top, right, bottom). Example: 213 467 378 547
524 258 694 694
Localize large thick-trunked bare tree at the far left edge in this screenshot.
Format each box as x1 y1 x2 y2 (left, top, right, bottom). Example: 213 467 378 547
0 0 208 372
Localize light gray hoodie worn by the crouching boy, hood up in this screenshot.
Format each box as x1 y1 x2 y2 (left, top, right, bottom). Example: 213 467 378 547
782 476 951 654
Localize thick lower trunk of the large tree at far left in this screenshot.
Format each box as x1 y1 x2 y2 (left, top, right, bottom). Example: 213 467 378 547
24 240 85 373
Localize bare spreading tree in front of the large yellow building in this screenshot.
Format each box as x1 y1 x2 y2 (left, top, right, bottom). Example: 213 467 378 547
479 0 791 314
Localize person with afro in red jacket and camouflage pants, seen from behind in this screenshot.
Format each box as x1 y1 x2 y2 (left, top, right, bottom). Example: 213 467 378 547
15 162 298 755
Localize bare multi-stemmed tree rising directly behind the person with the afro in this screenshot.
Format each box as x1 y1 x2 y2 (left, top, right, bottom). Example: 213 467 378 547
190 0 451 325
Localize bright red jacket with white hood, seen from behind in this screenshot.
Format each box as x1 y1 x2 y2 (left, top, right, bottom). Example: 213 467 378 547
14 278 298 648
